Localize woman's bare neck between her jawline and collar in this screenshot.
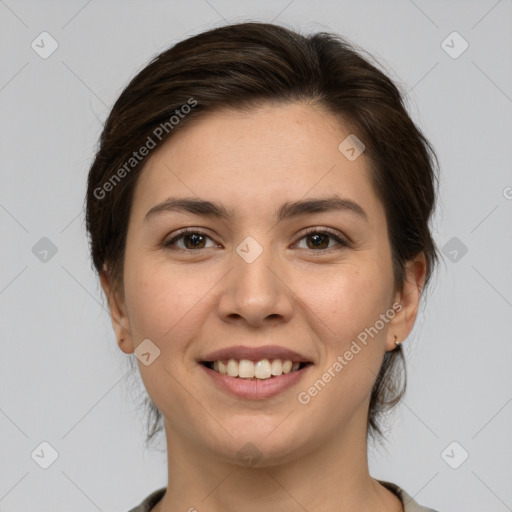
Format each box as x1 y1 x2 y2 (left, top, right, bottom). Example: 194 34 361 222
152 414 403 512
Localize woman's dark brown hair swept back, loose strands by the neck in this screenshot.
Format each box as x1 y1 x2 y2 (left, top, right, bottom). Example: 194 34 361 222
86 23 438 440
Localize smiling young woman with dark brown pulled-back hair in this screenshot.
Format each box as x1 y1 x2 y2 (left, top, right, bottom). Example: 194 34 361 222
87 23 437 512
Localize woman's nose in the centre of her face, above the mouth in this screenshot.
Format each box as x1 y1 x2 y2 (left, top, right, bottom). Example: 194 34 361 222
218 241 293 327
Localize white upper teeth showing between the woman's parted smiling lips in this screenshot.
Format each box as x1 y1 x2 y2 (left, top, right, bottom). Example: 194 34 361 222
201 359 312 380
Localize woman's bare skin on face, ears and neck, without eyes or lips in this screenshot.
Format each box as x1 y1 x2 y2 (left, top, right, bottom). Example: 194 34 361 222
101 103 426 512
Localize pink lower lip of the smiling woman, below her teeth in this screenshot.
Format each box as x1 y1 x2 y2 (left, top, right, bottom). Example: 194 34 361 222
201 364 311 400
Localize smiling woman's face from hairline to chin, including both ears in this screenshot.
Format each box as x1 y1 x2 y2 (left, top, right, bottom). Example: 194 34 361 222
102 104 421 464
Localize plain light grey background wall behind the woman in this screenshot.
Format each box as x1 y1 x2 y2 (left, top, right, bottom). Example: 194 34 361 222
0 0 512 512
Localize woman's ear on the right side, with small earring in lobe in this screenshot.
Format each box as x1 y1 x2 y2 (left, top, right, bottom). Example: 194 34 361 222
386 252 427 351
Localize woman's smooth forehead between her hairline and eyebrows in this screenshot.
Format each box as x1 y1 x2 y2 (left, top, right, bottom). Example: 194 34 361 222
133 104 380 224
